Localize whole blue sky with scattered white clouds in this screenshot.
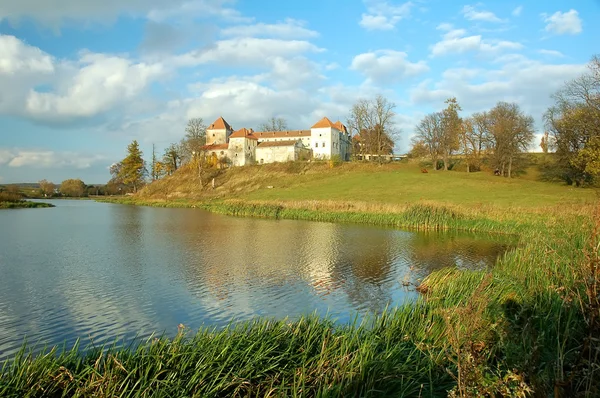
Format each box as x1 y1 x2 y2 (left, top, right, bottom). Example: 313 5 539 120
0 0 600 183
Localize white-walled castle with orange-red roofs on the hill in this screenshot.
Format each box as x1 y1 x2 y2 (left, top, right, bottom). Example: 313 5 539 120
202 117 352 166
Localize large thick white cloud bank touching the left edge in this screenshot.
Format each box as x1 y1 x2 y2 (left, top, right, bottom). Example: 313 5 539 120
0 36 168 123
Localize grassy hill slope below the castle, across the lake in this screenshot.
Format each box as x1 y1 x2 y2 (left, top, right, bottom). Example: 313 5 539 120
138 162 596 216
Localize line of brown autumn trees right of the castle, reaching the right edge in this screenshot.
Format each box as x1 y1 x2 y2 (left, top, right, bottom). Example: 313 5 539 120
410 56 600 186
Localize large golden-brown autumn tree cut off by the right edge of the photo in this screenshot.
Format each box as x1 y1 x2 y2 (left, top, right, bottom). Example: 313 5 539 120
544 56 600 186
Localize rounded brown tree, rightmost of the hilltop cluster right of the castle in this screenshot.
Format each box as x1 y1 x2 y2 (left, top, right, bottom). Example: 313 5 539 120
487 101 534 178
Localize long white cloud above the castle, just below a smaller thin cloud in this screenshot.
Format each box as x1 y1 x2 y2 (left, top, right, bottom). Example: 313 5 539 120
171 37 323 66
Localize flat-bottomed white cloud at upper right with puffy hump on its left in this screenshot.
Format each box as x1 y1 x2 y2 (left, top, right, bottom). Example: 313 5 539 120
431 29 523 57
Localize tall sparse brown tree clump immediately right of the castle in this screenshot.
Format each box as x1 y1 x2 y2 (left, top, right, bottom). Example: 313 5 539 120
347 95 399 162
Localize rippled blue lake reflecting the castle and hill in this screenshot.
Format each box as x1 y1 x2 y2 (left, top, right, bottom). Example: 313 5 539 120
0 200 511 358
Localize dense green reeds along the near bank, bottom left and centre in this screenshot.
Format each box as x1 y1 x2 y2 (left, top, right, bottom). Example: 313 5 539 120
0 310 454 397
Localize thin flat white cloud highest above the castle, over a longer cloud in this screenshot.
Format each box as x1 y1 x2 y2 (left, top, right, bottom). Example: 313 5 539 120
221 18 319 39
